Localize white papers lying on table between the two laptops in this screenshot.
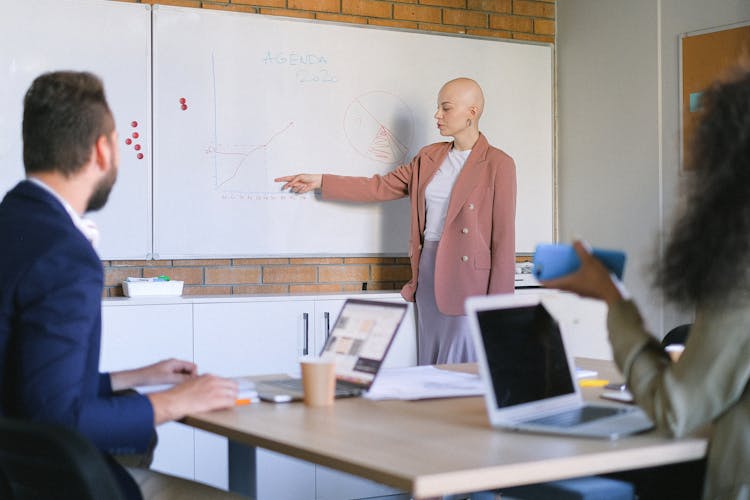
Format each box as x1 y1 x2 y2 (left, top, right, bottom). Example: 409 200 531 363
364 366 484 400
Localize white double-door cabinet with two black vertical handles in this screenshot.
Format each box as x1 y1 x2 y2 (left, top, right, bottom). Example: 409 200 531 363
193 297 416 500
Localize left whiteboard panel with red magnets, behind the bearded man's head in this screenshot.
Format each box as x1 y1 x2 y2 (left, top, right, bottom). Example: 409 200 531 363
0 0 152 259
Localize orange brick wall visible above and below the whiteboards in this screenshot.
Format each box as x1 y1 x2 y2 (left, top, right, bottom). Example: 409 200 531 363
104 0 555 297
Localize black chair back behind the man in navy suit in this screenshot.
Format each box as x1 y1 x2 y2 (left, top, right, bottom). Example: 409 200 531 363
0 418 125 500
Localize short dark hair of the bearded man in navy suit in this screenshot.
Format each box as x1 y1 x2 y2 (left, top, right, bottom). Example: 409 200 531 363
23 71 114 177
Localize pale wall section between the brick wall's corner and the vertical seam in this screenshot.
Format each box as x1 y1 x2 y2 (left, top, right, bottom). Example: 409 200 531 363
557 0 659 332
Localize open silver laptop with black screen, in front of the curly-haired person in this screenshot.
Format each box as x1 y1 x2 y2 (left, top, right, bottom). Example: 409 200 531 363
466 294 653 439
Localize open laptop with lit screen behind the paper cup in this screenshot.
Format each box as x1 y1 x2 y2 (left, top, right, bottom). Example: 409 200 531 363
255 299 408 403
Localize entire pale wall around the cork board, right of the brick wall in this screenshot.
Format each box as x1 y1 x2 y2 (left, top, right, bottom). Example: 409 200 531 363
557 0 750 336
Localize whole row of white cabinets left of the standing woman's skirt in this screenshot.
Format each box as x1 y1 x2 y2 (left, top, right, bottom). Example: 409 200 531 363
101 293 417 500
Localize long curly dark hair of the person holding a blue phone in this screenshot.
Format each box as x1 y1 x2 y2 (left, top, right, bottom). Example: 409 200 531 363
655 68 750 306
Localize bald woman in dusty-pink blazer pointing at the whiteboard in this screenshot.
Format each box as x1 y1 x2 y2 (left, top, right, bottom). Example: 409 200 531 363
276 78 516 365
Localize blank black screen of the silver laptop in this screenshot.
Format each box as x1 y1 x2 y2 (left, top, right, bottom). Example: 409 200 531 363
477 304 575 408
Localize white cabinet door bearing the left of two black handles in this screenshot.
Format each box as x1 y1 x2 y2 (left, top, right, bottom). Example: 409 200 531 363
194 300 315 500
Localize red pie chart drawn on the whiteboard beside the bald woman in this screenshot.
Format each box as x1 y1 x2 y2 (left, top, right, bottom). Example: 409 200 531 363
344 90 414 164
